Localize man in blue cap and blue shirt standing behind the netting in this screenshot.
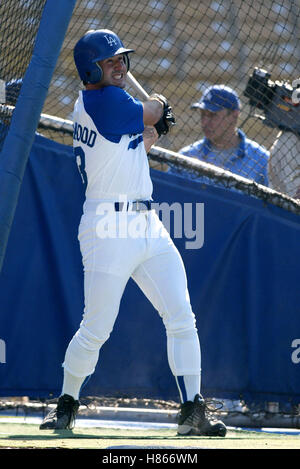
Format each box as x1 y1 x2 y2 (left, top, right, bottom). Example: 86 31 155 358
179 85 269 186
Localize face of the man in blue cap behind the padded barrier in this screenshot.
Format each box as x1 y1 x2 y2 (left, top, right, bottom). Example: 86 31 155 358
201 109 237 144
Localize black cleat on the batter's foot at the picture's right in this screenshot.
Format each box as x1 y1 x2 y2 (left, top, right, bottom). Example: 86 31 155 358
177 394 227 436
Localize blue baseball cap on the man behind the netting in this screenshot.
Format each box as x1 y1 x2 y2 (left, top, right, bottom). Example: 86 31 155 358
191 85 241 112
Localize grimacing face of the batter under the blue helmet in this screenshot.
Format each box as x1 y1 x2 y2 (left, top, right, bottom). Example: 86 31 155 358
99 54 127 88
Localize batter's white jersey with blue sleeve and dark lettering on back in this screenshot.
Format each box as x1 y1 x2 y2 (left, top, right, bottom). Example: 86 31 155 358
73 86 153 201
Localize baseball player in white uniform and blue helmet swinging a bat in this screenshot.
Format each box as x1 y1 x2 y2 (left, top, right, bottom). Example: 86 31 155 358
40 30 226 436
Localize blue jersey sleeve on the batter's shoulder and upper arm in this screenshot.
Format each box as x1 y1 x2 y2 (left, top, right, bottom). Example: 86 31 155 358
83 86 144 143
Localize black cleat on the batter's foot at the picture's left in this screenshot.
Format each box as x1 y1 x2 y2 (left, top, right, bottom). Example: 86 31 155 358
40 394 79 430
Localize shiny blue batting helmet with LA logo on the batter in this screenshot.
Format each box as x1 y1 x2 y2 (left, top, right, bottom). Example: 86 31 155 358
74 29 134 84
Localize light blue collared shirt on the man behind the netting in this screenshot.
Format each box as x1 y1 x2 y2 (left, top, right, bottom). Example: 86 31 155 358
173 129 269 186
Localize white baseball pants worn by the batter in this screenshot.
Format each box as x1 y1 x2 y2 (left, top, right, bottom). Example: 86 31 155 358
63 202 201 377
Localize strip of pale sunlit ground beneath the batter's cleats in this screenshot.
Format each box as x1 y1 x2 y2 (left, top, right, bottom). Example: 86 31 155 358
0 420 300 450
